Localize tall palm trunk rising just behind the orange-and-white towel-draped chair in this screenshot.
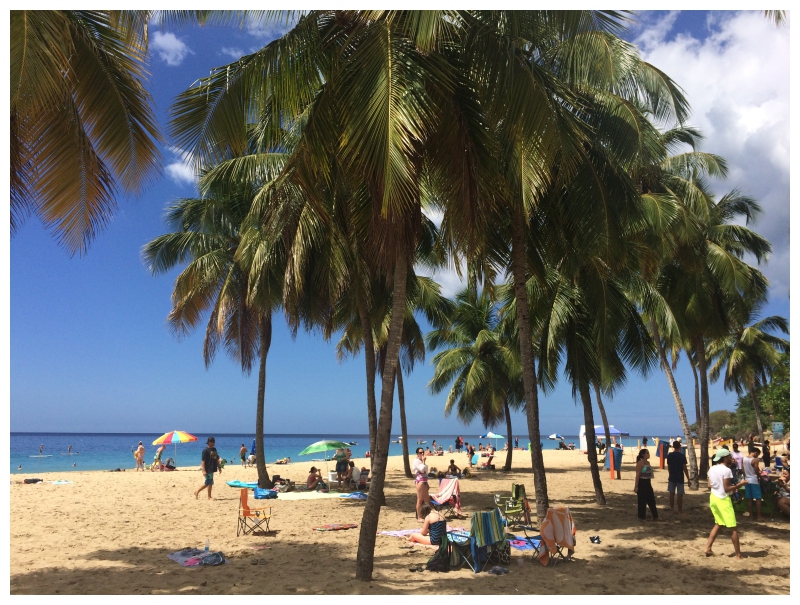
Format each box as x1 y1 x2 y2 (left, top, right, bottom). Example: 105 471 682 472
511 207 550 519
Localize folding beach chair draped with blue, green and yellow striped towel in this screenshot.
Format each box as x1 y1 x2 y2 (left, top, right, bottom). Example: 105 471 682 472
447 508 511 573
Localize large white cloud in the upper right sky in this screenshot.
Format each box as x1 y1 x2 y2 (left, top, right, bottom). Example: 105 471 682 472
636 12 790 299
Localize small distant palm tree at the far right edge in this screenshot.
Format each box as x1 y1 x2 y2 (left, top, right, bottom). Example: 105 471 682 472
707 301 789 439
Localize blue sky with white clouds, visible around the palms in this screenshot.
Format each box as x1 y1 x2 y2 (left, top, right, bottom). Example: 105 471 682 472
4 11 790 436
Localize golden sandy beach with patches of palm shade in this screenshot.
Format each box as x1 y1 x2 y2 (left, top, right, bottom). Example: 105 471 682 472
10 447 790 595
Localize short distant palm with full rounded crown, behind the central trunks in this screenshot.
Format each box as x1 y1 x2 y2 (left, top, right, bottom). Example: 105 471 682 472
425 286 523 471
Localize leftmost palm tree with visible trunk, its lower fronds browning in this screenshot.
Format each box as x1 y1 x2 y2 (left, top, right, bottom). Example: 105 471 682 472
142 177 286 487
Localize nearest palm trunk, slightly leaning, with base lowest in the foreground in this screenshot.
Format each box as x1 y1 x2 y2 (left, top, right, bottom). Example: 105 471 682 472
356 244 408 581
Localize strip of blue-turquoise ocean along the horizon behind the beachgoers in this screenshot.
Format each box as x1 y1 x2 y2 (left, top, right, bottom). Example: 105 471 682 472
10 433 667 475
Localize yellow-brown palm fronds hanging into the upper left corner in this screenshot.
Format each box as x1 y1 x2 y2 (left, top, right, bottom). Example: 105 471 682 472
10 10 163 254
